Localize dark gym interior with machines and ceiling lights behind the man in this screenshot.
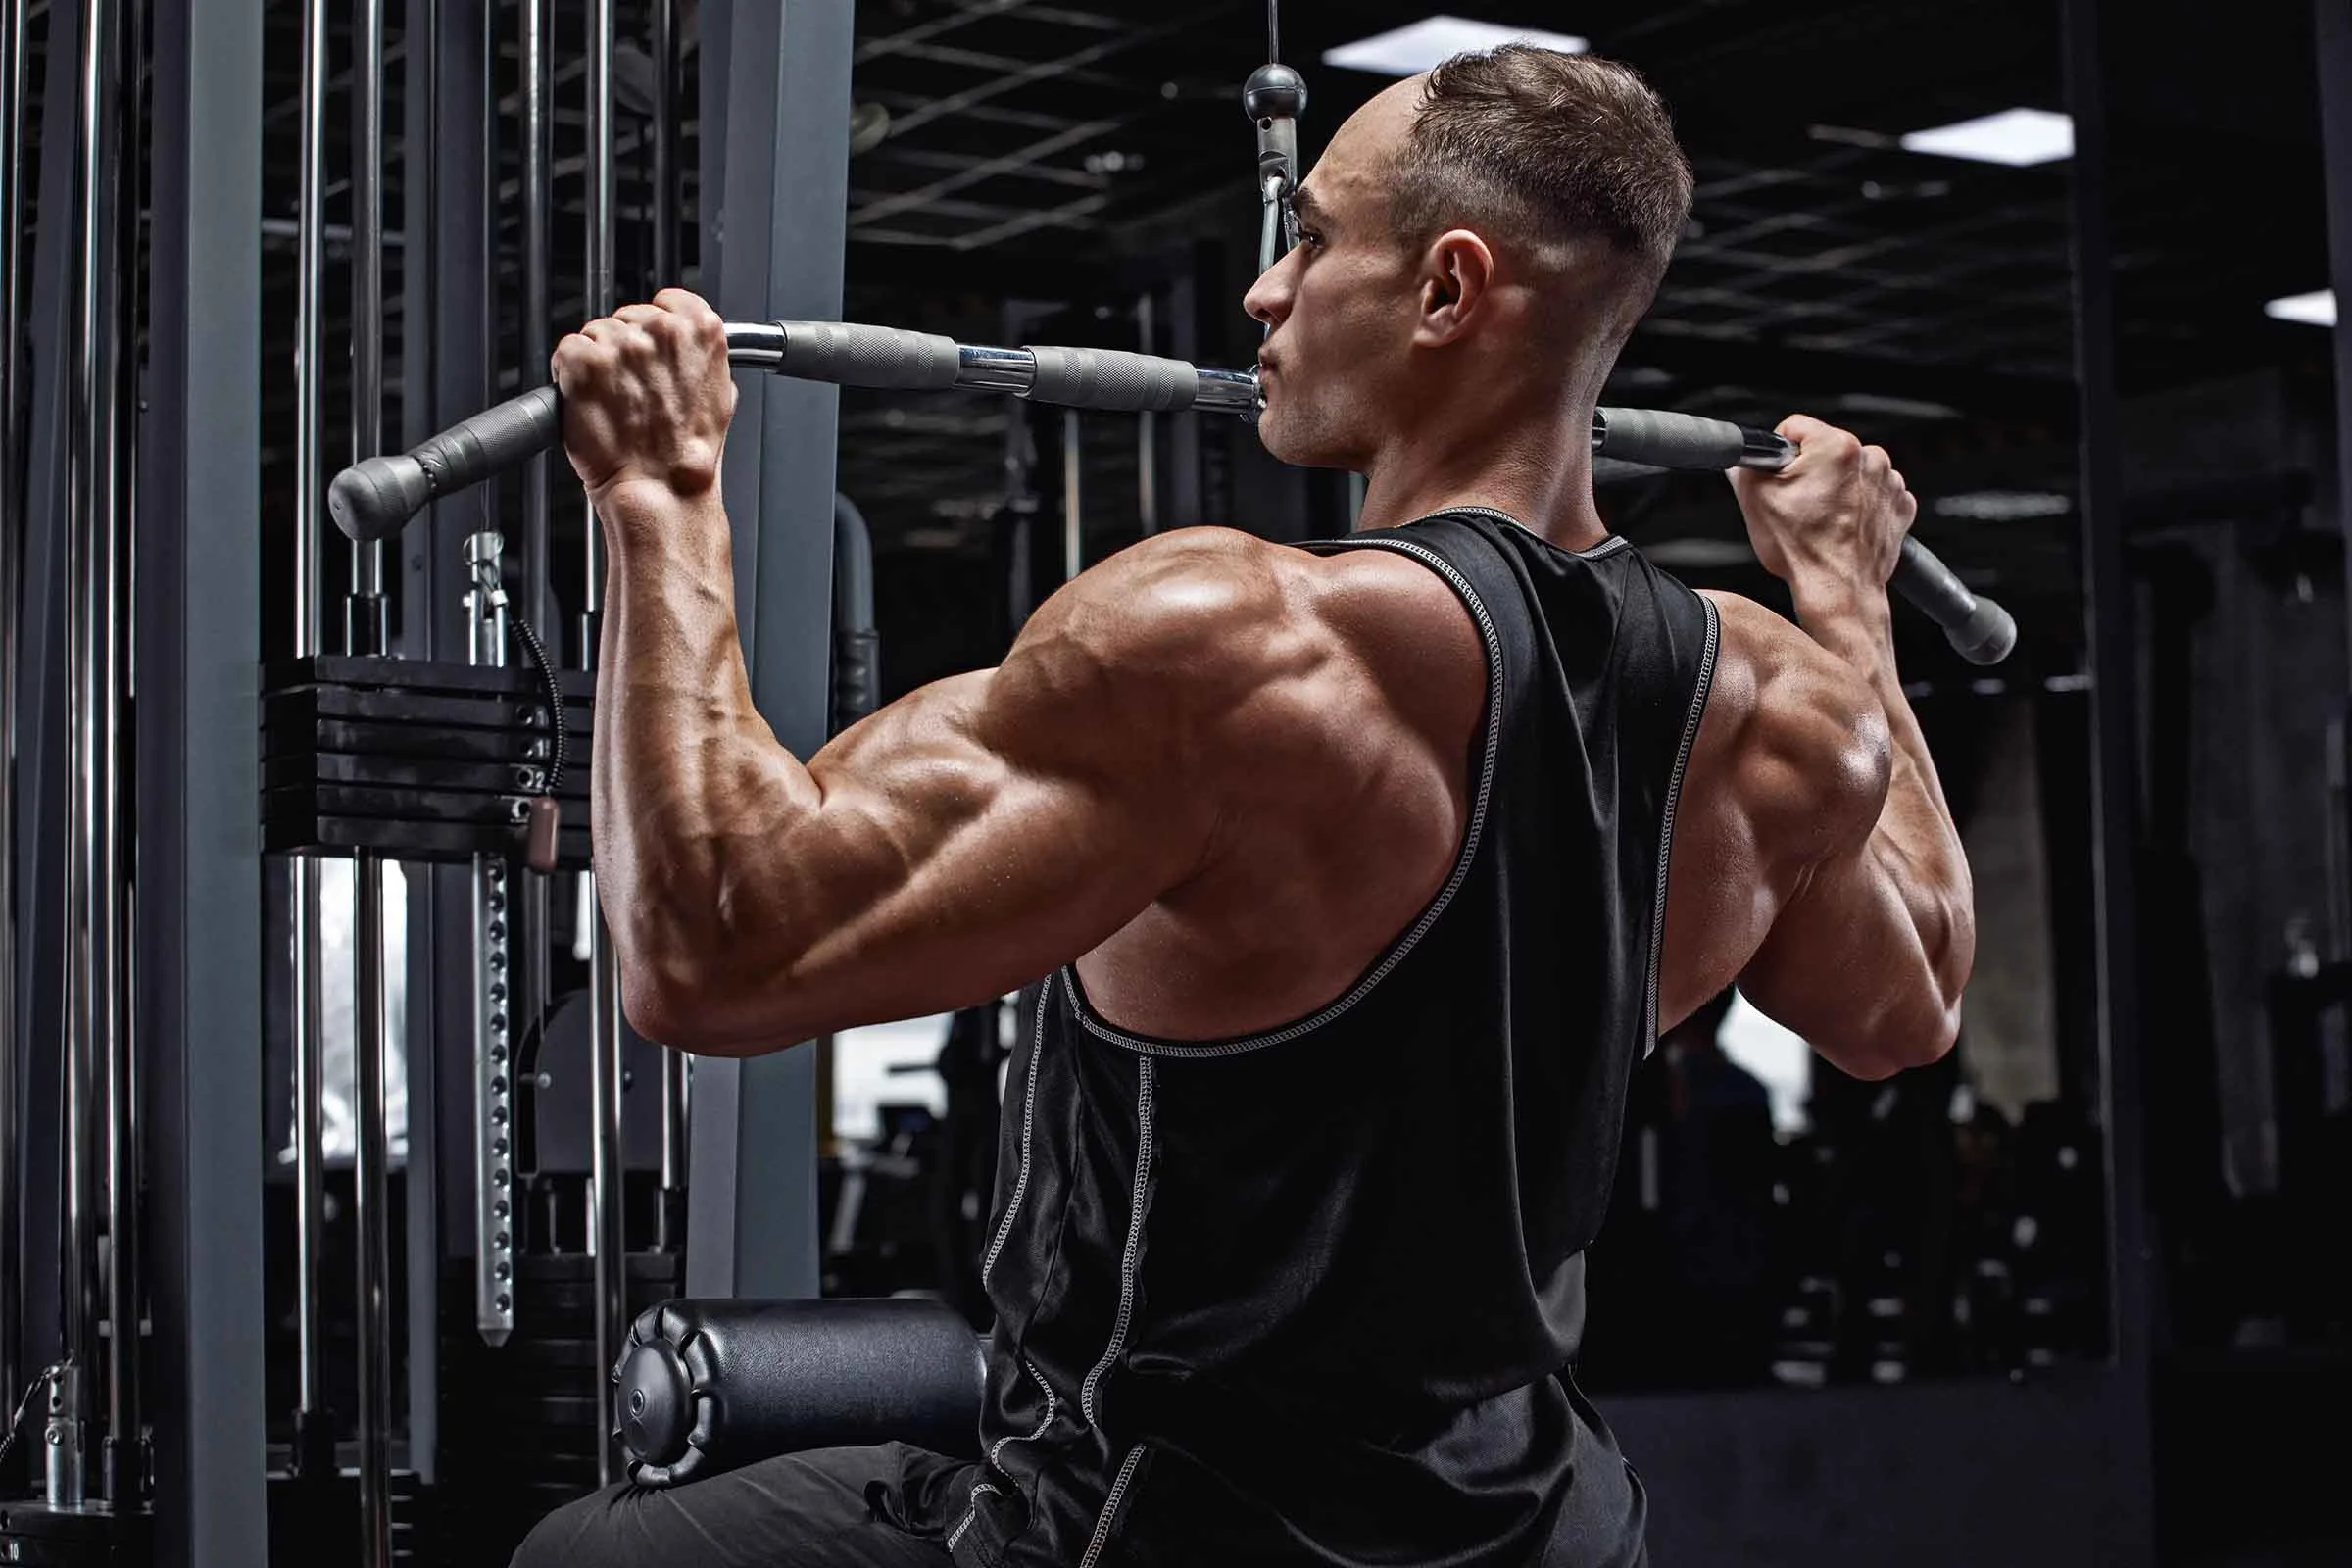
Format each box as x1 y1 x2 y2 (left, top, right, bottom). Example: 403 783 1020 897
0 0 2352 1568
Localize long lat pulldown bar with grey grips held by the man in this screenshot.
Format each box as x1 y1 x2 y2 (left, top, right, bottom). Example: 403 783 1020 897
327 322 2018 665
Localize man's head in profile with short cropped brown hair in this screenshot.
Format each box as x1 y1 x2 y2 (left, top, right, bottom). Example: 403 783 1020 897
1247 45 1691 467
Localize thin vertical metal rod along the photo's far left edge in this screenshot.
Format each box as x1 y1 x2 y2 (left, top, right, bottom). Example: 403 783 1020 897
0 0 24 1398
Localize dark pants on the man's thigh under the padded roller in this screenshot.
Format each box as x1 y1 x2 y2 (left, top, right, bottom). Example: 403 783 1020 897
513 1444 981 1568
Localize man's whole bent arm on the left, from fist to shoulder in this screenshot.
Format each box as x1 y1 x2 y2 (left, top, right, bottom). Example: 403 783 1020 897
555 294 1268 1055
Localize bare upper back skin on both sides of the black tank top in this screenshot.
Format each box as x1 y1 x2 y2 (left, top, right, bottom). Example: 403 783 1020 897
1077 529 1884 1062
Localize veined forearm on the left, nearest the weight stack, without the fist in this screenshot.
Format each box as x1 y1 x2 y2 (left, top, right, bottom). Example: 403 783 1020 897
593 484 818 1022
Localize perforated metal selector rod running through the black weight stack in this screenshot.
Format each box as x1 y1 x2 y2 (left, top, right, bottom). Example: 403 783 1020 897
466 529 513 1348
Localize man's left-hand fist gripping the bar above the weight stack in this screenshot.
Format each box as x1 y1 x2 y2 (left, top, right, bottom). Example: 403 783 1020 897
553 289 736 501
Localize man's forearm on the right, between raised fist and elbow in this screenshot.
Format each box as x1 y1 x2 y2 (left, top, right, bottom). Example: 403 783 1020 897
1792 573 1976 997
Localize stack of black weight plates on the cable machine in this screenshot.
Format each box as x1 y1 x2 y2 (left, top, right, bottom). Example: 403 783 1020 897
261 654 595 870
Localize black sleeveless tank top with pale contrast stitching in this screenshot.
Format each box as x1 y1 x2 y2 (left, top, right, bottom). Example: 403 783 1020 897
951 511 1717 1568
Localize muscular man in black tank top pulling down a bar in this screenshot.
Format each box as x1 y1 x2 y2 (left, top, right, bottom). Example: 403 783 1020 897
517 47 1974 1568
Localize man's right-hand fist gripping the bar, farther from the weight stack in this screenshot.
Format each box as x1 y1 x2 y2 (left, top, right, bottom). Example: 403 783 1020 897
1731 414 1919 590
